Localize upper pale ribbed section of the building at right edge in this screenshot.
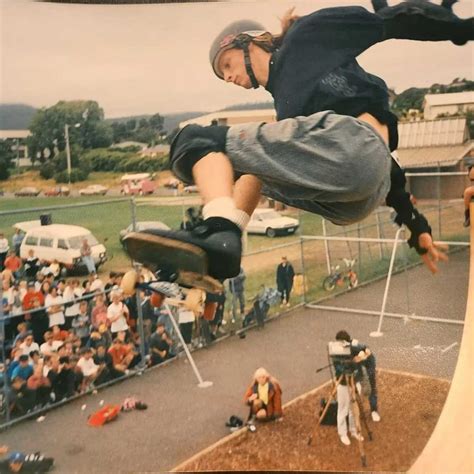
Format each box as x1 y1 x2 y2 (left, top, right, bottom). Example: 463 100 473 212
398 117 469 150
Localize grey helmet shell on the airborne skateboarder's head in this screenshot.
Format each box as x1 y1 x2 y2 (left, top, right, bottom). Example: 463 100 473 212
209 20 267 79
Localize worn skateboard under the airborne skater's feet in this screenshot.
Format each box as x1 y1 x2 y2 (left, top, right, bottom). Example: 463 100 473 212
123 232 224 293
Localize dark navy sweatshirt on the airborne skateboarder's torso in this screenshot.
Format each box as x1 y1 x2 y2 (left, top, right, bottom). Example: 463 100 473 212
266 7 398 150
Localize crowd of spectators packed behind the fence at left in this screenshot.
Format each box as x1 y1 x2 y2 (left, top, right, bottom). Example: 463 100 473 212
0 243 223 417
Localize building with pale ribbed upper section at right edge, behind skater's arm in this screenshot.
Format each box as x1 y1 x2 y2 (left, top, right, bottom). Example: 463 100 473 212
397 117 474 199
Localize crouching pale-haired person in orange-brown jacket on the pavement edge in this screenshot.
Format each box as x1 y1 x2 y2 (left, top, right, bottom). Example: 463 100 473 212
244 367 283 421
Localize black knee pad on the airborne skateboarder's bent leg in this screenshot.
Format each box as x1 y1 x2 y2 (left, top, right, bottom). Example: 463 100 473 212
170 125 229 184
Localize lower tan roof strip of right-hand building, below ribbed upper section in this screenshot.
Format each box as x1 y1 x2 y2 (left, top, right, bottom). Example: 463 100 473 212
397 140 474 168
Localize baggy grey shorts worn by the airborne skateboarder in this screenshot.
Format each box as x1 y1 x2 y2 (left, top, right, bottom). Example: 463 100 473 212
226 111 391 225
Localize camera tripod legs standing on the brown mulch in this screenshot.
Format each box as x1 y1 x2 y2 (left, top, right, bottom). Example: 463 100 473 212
308 372 372 467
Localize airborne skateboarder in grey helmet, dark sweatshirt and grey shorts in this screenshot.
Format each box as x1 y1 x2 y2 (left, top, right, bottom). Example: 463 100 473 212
122 1 473 279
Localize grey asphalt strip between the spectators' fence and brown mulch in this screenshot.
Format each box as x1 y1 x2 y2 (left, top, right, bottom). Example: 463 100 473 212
0 252 468 473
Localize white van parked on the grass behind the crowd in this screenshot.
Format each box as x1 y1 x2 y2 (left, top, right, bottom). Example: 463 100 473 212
19 223 107 272
